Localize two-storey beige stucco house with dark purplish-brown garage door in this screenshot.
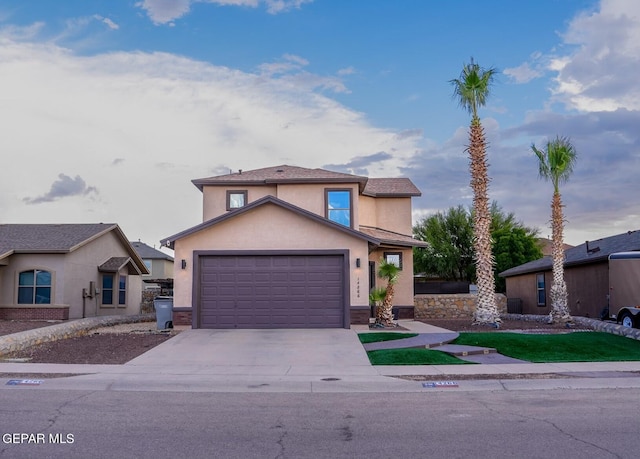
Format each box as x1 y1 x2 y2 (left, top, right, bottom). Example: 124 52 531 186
161 165 424 328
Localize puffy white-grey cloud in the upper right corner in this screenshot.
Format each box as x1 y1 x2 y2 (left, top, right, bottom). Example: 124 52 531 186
549 0 640 112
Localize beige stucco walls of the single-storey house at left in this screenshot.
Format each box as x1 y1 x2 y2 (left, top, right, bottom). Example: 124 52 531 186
0 232 142 319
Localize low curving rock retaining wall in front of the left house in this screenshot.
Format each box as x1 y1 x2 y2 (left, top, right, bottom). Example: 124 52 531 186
0 314 155 356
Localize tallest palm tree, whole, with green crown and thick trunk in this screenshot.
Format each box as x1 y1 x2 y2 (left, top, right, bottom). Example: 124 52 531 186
450 58 500 327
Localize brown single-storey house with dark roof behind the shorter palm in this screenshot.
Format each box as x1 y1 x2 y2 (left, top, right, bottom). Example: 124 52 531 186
500 230 640 317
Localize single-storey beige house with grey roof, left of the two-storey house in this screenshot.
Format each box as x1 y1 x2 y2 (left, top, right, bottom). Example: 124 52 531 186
0 223 147 320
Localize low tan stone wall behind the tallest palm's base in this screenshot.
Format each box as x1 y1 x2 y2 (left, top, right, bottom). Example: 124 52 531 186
413 293 507 320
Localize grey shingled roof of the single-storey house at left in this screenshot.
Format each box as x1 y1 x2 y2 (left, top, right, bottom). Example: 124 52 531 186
0 223 148 274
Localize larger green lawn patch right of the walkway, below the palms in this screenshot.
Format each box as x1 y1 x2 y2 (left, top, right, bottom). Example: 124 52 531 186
452 332 640 363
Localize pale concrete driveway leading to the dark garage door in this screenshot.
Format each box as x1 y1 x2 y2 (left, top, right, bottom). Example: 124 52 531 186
127 329 377 375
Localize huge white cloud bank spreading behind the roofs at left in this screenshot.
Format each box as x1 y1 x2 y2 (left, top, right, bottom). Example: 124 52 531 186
0 37 420 241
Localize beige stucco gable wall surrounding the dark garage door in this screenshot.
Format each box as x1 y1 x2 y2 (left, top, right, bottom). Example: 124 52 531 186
173 204 369 307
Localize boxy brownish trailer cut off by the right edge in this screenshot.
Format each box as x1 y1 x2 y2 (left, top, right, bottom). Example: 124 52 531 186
608 252 640 328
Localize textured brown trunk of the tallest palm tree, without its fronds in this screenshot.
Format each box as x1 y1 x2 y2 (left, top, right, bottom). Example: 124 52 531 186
468 117 500 325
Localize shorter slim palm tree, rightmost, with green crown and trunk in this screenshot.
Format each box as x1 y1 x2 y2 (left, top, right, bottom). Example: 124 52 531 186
531 136 576 323
